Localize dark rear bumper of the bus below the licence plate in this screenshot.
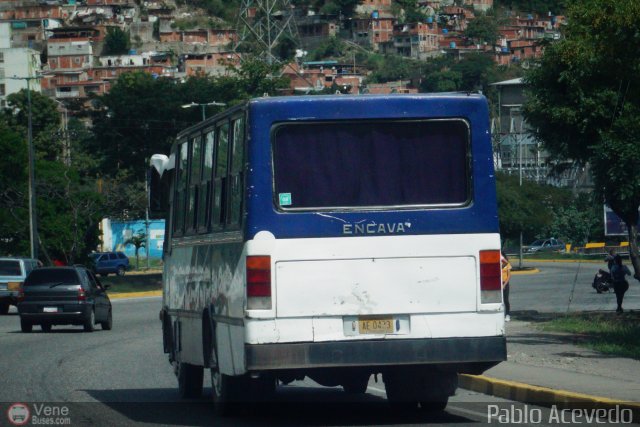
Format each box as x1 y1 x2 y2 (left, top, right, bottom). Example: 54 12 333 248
245 336 507 373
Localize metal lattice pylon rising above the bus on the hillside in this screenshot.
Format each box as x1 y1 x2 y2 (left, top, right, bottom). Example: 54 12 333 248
235 0 298 64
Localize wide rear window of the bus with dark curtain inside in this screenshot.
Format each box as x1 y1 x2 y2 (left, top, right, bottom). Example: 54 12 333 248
273 120 470 210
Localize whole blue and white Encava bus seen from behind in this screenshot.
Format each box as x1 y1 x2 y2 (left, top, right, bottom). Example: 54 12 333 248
152 94 506 411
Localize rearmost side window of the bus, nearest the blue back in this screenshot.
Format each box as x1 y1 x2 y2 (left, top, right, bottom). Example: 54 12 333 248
227 117 244 227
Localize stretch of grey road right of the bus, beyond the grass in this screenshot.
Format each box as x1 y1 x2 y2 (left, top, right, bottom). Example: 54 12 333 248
509 257 640 313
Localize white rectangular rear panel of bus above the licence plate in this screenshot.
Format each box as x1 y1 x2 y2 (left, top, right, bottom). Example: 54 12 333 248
276 256 478 317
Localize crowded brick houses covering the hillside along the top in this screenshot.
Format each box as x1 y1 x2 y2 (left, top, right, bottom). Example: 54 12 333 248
0 0 563 112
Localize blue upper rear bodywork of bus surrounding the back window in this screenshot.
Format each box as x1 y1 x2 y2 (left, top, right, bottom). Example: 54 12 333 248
246 93 498 239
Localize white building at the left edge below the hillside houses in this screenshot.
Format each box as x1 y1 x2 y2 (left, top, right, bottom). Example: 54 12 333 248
0 47 41 107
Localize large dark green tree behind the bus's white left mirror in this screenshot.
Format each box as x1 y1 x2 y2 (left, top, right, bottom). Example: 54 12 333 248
87 61 288 219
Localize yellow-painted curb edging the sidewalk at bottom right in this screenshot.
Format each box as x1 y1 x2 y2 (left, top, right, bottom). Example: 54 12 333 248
458 374 640 422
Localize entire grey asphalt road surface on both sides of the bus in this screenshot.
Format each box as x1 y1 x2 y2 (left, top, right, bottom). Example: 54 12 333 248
0 264 640 426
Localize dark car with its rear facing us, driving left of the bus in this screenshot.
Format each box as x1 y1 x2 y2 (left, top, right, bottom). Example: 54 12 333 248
18 266 113 332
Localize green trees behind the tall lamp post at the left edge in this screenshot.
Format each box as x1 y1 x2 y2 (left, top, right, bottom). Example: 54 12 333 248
0 91 102 262
